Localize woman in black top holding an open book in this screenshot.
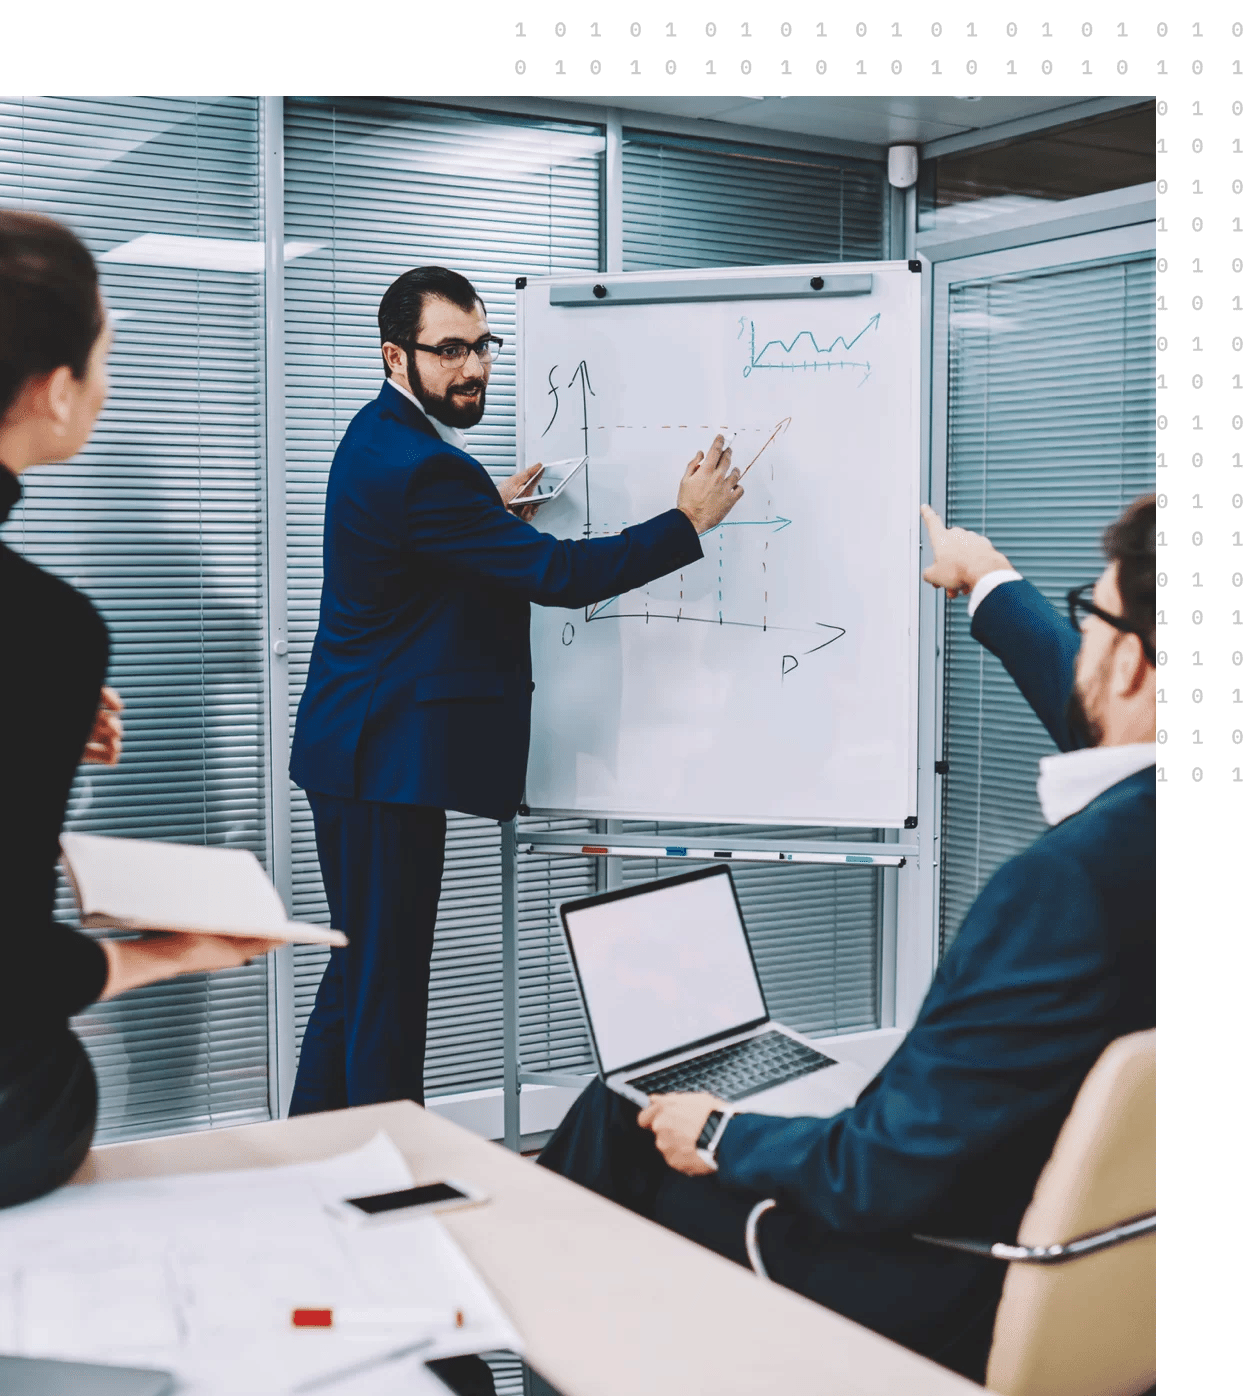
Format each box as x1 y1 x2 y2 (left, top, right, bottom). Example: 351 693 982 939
0 209 276 1206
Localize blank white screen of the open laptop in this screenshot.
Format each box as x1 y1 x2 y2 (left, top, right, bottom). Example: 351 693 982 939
562 868 768 1075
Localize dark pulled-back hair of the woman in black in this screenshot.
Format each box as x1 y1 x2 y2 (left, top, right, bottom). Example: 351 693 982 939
0 208 105 419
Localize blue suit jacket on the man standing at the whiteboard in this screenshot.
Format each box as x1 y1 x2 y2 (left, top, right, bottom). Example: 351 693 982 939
290 384 702 819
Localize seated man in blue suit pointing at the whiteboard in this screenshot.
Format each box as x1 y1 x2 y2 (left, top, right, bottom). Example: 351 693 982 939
540 496 1156 1381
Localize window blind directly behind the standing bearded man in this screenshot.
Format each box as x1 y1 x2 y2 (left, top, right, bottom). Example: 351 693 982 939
285 99 604 1094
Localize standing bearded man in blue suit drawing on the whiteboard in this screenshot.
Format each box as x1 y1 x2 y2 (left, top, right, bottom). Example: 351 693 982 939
290 267 742 1114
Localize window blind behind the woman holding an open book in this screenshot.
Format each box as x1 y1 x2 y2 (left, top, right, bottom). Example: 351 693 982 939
0 96 268 1142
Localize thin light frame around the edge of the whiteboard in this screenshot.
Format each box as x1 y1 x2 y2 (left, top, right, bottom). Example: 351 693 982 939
515 258 934 826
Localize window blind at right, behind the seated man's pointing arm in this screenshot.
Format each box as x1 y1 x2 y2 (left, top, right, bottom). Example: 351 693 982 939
941 255 1156 949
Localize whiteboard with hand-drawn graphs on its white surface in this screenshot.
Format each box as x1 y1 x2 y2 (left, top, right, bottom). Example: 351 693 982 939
518 262 921 828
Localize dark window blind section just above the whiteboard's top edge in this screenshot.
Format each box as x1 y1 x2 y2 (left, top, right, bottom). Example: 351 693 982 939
624 130 889 271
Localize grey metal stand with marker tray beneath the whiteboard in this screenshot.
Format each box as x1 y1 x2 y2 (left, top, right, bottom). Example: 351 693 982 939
501 819 920 1153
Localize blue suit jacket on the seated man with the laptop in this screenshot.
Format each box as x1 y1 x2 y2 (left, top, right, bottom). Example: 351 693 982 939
717 581 1156 1241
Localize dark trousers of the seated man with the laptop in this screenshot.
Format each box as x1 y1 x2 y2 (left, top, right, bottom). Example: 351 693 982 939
540 1081 1005 1382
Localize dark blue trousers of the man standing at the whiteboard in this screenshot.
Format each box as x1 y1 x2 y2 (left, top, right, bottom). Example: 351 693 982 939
289 792 445 1115
